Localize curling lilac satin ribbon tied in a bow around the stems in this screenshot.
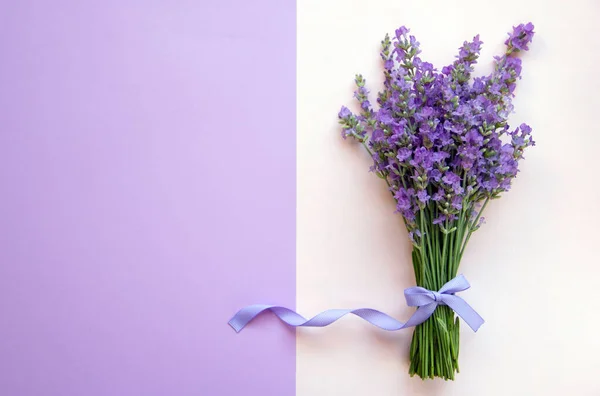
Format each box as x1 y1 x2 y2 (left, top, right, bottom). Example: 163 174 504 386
229 275 484 333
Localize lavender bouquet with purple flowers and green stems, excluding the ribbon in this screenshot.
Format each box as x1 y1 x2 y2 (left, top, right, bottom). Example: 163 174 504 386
338 23 534 379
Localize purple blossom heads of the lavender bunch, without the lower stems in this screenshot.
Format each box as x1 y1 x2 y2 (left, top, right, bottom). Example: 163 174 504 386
338 23 534 241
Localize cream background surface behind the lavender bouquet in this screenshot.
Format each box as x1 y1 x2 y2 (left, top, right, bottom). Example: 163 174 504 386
297 0 600 396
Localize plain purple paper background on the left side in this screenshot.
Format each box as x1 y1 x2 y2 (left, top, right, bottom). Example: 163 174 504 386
0 0 296 396
